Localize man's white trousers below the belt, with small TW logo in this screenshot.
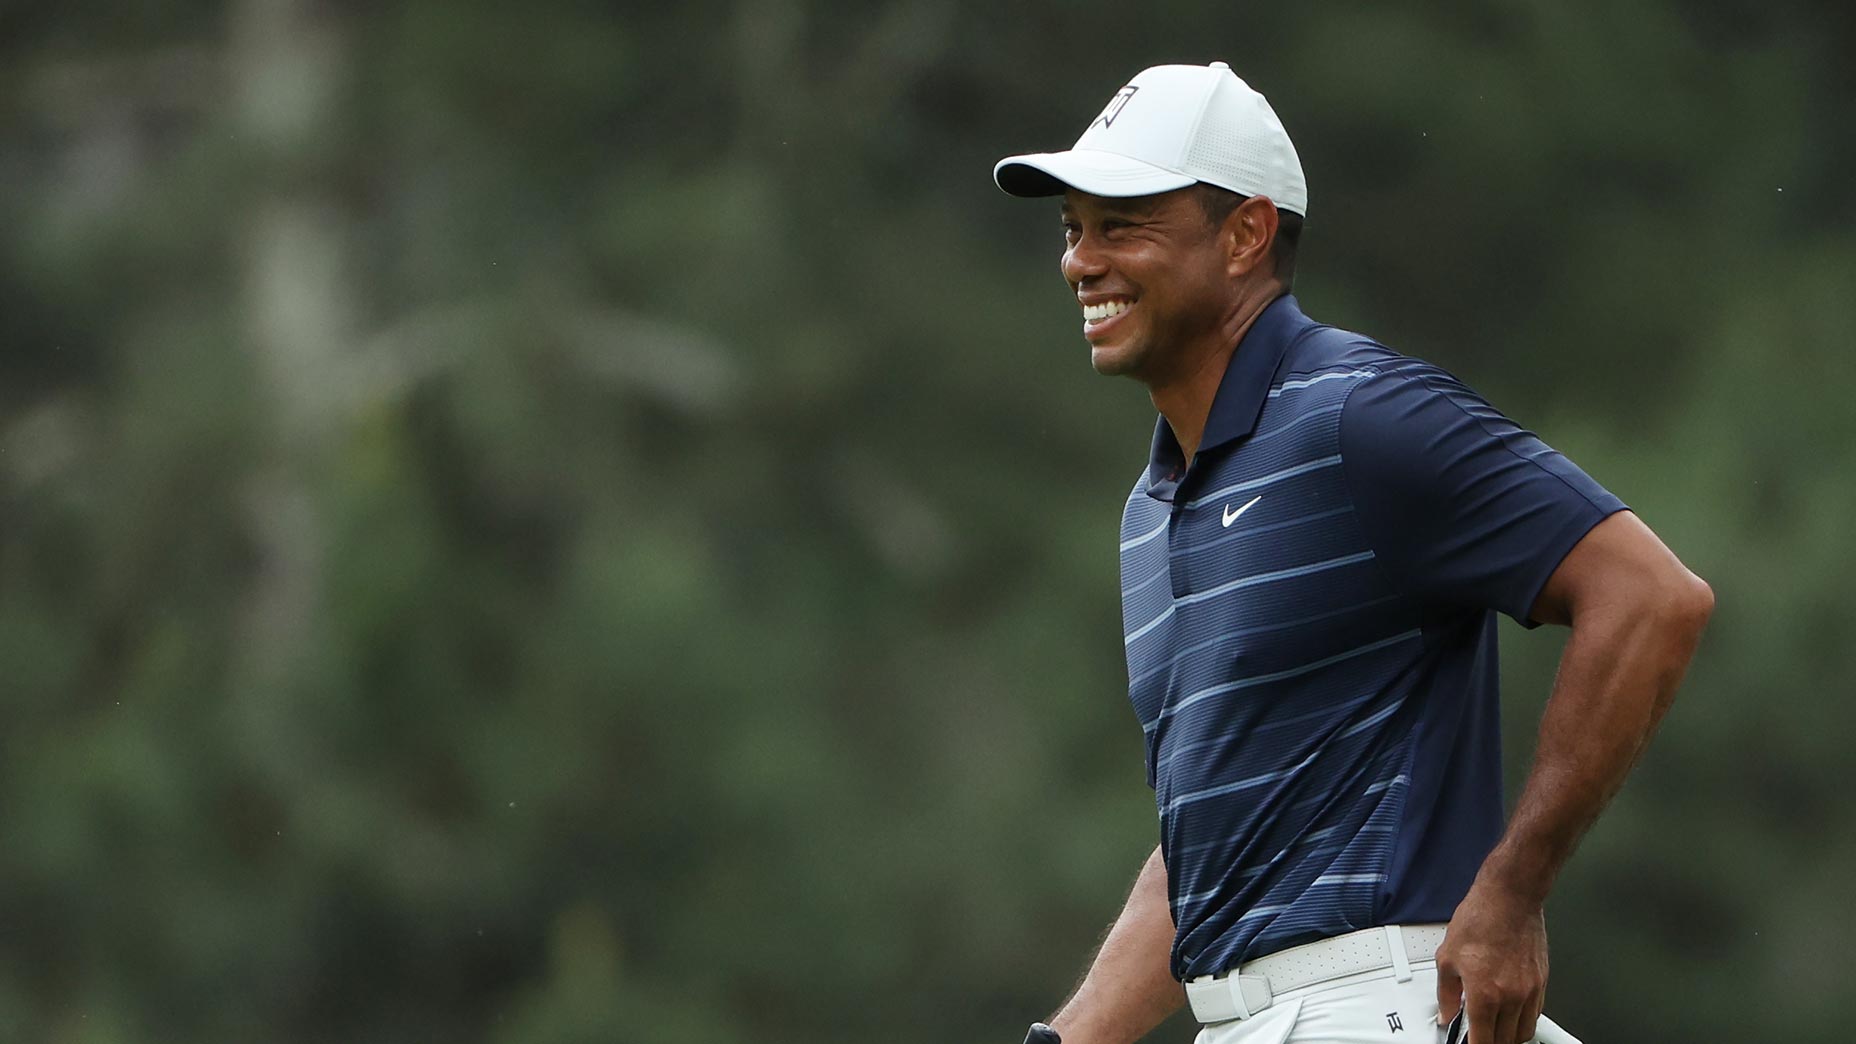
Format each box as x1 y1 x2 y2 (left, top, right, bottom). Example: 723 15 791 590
1197 960 1579 1044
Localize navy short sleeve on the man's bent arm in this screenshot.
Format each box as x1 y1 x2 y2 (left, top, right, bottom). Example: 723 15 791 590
1340 366 1624 628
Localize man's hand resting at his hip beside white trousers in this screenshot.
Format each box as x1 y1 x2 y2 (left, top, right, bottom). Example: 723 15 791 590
1437 881 1546 1044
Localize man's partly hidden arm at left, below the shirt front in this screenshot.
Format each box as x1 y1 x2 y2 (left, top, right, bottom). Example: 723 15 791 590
1050 849 1186 1044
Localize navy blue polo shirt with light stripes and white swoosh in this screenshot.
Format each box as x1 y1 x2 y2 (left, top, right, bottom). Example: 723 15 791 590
1121 289 1624 979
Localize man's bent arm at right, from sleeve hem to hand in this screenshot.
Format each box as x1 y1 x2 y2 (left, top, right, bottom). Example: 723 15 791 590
1437 511 1715 1044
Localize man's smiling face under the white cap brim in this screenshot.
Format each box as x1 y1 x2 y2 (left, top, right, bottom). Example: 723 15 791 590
1063 188 1231 377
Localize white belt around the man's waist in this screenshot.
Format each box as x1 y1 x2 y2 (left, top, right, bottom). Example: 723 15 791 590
1186 925 1446 1025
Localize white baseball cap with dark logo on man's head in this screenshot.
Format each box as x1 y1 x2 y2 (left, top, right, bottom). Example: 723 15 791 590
993 61 1308 217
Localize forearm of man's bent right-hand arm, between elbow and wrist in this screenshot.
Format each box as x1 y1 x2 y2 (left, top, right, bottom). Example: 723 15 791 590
1477 564 1713 905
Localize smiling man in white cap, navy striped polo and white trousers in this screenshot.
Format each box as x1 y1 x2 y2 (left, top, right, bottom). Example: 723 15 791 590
995 63 1713 1044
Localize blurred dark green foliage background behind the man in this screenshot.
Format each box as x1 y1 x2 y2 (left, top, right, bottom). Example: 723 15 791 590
0 0 1856 1044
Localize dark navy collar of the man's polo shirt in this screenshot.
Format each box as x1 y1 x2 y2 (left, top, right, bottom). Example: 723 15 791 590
1147 294 1316 502
